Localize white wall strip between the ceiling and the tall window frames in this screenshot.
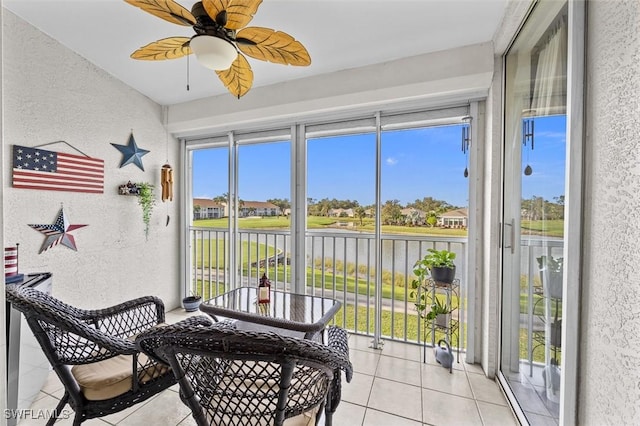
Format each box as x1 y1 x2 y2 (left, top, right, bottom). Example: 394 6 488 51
169 42 493 136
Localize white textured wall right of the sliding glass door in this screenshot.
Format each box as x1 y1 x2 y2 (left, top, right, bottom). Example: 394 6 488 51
578 0 640 425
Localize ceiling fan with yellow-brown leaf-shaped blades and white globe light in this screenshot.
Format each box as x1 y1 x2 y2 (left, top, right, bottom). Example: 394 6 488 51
124 0 311 98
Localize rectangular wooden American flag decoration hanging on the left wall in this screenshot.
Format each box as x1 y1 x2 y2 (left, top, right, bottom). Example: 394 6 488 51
12 145 104 194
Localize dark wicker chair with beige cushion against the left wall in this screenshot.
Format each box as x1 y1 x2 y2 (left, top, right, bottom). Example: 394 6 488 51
5 285 211 425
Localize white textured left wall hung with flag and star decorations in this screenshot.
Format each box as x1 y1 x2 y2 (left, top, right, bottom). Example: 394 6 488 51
2 10 180 308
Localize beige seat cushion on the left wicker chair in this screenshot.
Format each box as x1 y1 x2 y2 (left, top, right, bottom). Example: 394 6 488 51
71 353 169 401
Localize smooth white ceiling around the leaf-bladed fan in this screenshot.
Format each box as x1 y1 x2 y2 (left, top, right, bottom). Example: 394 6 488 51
3 0 508 105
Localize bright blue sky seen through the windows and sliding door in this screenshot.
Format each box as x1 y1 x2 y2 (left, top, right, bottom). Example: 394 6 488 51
193 117 565 206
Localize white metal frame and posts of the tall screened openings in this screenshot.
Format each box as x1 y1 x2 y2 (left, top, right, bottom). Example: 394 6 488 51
180 99 484 352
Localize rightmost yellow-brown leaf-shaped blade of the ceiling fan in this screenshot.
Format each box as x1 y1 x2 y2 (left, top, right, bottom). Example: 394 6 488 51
236 27 311 66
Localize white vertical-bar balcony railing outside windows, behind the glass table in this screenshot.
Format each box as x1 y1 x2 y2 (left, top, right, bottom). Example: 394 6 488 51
186 227 467 346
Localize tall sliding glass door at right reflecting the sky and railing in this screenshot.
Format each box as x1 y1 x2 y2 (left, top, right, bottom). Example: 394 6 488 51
500 1 568 424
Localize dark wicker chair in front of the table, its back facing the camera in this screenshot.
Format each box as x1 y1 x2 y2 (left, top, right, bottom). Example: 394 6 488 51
136 324 352 426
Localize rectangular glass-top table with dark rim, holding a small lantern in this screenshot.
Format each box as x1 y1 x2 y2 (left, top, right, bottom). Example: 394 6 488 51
200 287 342 339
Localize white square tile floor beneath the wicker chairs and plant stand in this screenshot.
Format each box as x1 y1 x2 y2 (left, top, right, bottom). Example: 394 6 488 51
18 309 518 426
